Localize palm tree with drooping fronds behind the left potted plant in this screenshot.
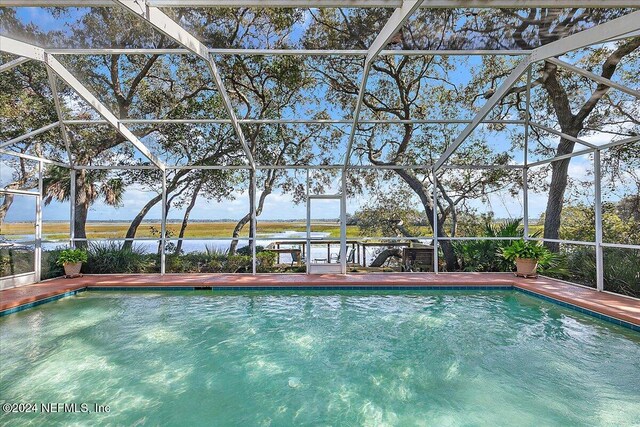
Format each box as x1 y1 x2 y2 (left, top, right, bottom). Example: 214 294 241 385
42 165 125 247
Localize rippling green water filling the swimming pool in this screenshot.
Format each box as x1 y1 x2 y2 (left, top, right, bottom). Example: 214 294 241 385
0 291 640 426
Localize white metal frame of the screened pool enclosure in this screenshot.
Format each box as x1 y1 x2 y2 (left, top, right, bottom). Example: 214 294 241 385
0 0 640 291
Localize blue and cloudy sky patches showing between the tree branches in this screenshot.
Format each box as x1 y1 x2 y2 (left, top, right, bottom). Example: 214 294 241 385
0 8 636 227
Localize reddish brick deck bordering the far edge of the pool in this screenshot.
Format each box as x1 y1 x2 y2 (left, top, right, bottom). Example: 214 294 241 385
0 273 640 326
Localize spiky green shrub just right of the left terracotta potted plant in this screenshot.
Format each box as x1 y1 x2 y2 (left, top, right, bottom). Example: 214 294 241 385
82 242 157 274
